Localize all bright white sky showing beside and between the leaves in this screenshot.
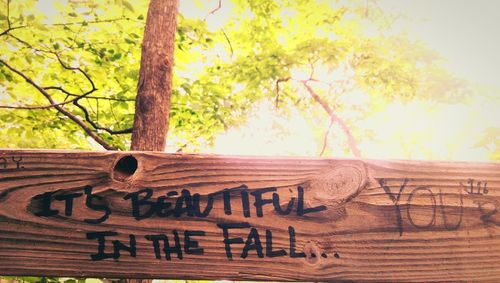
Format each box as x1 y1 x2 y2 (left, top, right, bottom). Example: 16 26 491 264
181 0 500 161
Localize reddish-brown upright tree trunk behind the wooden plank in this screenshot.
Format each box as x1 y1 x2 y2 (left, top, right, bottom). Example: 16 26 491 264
131 0 179 151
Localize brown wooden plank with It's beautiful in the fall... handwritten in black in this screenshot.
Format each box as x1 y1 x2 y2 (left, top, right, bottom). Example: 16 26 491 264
0 150 500 282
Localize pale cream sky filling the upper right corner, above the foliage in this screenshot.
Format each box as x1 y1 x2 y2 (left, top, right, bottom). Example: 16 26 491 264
380 0 500 87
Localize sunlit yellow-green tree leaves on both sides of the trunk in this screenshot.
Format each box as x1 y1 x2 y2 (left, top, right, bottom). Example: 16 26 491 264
0 0 466 154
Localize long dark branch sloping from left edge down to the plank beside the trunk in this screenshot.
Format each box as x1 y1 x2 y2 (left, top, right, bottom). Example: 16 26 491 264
0 59 116 150
